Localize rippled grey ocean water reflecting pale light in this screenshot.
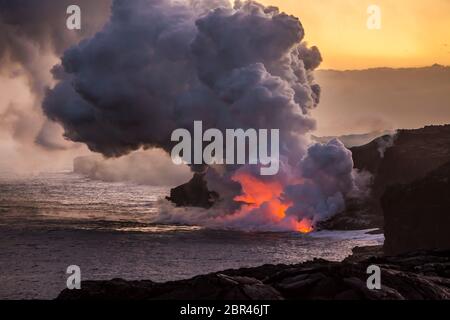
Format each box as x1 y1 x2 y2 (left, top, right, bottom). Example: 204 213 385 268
0 172 383 299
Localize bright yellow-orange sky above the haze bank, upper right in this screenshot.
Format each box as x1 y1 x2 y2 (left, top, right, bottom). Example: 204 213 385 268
259 0 450 69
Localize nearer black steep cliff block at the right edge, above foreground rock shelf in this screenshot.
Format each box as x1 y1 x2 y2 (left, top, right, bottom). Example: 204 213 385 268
381 162 450 254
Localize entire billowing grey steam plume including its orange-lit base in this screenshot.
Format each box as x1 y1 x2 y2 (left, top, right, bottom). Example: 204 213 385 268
43 0 366 230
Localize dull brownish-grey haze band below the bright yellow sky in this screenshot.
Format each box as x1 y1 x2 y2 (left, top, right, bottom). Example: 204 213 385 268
313 66 450 135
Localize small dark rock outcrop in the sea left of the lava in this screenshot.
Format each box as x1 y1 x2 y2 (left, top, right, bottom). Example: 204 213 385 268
167 173 219 209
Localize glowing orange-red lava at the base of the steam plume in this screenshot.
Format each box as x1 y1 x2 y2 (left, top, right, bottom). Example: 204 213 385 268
233 172 313 233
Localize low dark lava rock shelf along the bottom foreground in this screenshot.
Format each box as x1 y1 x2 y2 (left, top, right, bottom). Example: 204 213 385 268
58 250 450 300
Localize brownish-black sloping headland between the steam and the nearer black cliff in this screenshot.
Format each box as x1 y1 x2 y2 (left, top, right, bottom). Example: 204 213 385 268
319 125 450 230
